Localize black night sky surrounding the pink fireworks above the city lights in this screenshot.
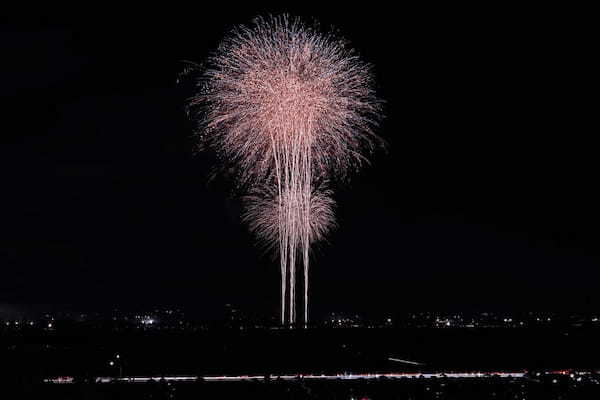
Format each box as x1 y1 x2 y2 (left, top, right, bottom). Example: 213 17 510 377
0 4 600 315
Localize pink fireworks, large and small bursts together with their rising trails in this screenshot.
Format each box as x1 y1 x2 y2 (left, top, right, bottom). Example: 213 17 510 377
190 16 380 323
